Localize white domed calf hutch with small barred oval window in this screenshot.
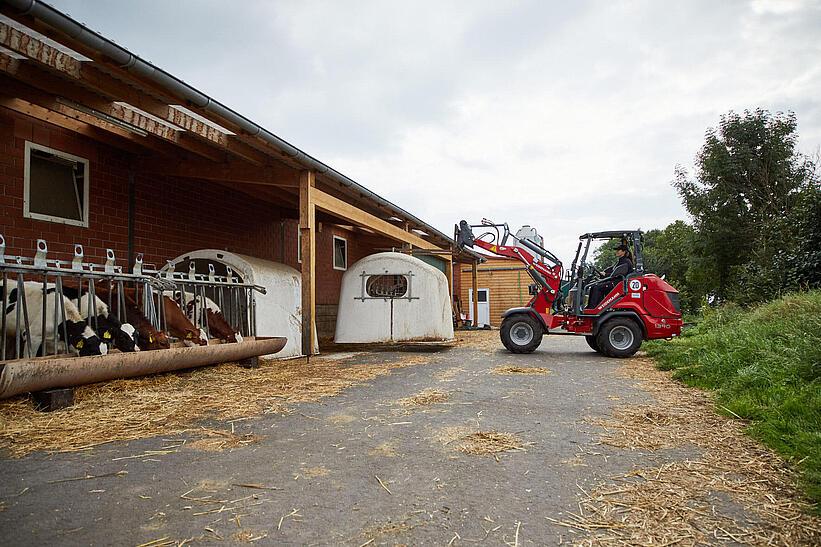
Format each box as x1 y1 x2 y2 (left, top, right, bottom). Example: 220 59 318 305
334 253 453 344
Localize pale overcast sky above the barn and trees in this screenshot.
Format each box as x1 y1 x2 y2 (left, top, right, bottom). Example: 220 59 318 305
52 0 821 262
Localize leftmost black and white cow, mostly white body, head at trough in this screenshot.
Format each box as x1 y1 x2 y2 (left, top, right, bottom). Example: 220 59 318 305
4 281 108 357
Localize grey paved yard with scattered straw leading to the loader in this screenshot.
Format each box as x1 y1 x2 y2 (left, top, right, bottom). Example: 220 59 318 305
0 332 808 546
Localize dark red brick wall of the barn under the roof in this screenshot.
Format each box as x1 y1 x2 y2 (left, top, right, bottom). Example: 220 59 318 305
0 108 386 305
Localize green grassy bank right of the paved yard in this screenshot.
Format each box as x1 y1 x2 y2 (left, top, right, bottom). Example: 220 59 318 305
646 291 821 512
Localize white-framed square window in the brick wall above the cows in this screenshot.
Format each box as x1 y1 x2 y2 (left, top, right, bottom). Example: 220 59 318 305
23 142 88 227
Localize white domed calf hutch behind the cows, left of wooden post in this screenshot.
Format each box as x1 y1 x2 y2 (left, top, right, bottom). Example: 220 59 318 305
163 249 319 358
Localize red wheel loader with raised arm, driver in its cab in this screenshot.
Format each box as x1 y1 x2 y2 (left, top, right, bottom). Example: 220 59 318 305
454 220 682 357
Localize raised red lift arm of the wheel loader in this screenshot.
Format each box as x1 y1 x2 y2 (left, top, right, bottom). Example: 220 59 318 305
454 220 562 306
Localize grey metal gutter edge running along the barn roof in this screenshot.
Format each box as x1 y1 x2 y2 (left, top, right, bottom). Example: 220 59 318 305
2 0 468 252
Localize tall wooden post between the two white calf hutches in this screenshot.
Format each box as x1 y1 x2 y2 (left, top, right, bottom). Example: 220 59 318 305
299 171 316 356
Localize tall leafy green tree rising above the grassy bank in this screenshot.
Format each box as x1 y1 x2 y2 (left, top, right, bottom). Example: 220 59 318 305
673 109 818 303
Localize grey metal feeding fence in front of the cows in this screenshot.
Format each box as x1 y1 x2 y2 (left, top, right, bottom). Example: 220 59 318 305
0 235 265 361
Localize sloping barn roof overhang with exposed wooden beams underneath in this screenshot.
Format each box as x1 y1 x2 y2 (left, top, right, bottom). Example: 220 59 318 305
0 0 475 260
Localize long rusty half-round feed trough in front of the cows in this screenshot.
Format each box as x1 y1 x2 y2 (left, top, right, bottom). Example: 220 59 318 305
0 337 286 399
